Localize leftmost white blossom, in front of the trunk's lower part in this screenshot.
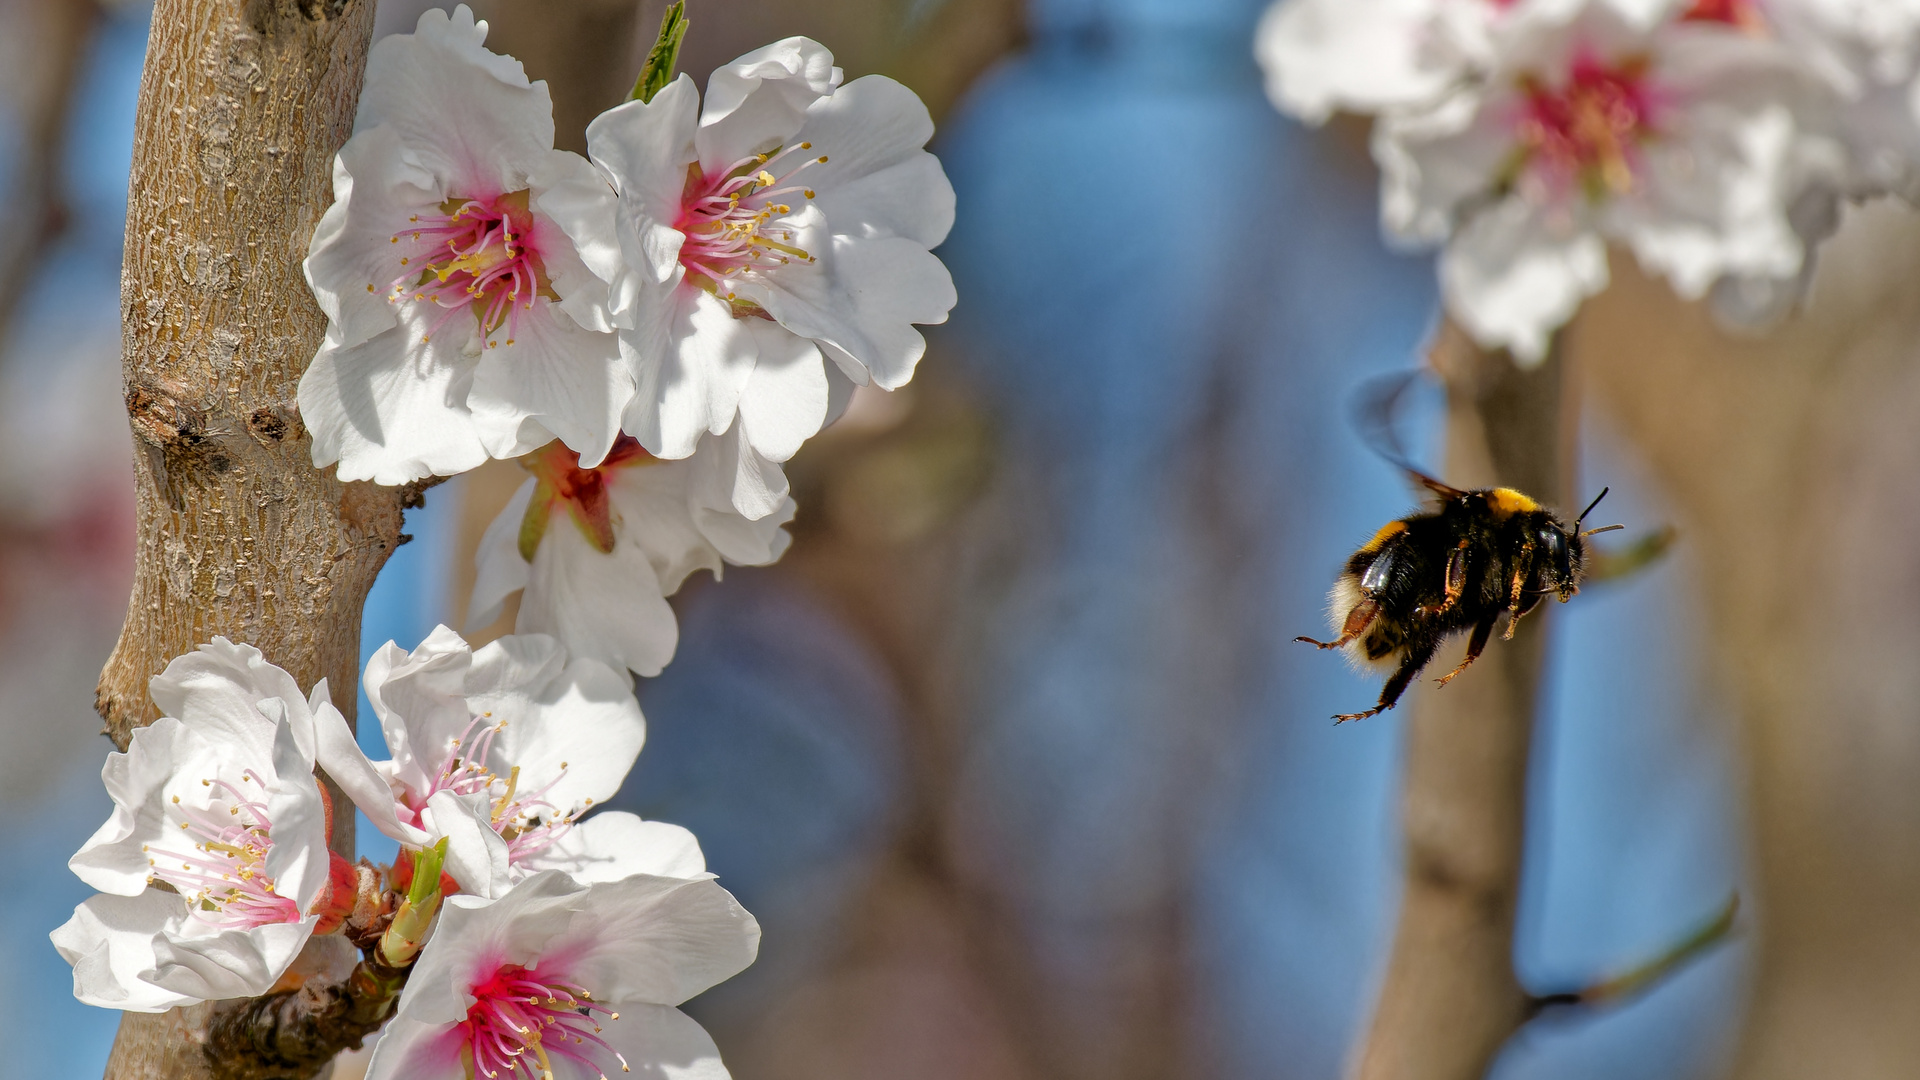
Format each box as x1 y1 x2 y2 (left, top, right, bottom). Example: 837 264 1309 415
54 638 355 1013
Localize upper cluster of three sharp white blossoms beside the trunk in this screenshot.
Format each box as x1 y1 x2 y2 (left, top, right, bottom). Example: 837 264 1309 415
300 8 954 675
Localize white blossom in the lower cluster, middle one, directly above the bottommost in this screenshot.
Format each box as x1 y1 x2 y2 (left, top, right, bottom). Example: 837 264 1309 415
317 626 647 896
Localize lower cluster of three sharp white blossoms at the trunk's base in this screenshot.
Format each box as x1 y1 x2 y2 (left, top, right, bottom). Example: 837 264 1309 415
54 626 760 1078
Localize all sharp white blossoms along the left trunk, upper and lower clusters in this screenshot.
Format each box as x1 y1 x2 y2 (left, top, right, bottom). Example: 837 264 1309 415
54 6 954 1080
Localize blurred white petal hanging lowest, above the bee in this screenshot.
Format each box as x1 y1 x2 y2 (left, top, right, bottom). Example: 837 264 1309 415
1440 198 1607 365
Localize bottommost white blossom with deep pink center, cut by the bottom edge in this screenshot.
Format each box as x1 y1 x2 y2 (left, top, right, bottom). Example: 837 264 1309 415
367 864 760 1080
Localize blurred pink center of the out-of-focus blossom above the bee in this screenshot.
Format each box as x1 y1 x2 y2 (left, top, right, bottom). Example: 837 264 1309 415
1517 56 1657 202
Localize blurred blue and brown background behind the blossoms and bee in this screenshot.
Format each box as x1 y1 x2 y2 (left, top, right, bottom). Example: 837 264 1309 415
22 0 1920 1080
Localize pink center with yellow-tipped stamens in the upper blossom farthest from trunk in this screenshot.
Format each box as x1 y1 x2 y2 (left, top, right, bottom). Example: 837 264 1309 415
674 142 828 300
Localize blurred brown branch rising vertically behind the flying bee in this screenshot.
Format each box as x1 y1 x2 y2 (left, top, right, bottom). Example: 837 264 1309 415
1356 319 1572 1080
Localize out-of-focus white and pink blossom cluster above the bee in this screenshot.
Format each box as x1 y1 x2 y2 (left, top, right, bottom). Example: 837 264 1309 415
1258 0 1920 361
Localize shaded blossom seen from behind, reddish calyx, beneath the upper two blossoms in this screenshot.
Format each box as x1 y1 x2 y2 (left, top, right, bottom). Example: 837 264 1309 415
467 436 793 676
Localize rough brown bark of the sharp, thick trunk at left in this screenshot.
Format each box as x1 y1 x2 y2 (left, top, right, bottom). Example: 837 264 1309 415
98 0 397 1080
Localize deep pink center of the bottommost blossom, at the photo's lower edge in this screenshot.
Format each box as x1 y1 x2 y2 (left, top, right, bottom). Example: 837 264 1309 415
459 965 628 1080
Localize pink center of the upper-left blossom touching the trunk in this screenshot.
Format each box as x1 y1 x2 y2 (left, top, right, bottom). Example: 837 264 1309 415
387 190 559 348
